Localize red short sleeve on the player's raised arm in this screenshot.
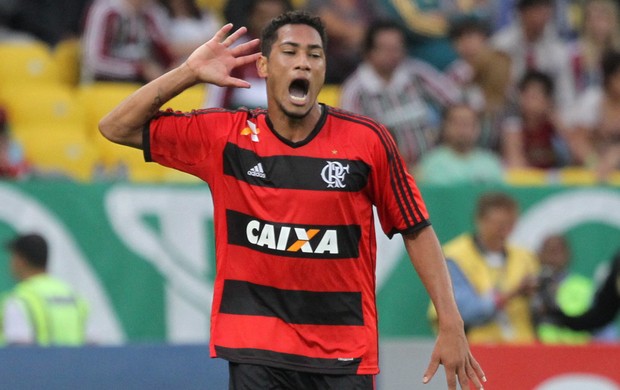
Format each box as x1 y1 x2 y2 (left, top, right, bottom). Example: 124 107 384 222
143 110 234 178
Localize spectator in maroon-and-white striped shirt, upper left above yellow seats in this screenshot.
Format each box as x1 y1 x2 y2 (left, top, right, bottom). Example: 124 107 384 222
82 0 174 83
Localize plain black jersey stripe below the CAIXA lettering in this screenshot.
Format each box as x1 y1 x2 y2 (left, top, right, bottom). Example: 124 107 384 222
220 279 364 326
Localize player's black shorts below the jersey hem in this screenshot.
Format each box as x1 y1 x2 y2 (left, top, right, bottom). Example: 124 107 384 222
228 362 375 390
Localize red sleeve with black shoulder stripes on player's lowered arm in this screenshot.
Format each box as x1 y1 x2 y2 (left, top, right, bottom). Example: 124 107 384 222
371 125 430 238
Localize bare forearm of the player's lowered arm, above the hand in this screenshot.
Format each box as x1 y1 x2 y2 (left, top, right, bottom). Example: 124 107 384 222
403 227 463 330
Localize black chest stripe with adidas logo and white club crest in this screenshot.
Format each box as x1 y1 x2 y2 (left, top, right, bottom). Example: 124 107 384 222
224 143 370 192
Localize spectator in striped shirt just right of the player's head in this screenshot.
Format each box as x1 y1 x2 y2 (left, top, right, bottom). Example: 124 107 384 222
340 21 460 166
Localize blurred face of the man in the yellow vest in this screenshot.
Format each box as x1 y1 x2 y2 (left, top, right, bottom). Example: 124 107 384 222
477 207 518 251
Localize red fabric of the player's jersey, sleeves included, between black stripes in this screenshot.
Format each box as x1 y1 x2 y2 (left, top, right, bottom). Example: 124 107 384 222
146 107 429 374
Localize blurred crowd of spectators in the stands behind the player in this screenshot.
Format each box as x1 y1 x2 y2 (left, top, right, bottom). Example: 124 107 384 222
0 0 620 184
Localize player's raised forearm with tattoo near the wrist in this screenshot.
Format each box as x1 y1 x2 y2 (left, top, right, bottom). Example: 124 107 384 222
99 64 197 148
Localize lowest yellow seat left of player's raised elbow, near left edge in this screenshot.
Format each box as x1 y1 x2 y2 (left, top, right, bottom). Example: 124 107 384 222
15 124 99 181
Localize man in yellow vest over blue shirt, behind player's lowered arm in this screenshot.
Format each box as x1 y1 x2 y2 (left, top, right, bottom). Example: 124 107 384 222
429 192 539 344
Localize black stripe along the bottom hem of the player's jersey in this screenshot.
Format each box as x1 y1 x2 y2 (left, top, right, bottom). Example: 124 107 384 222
215 345 362 375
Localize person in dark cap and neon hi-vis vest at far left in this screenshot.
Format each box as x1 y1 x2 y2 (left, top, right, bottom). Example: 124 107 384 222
0 234 92 346
